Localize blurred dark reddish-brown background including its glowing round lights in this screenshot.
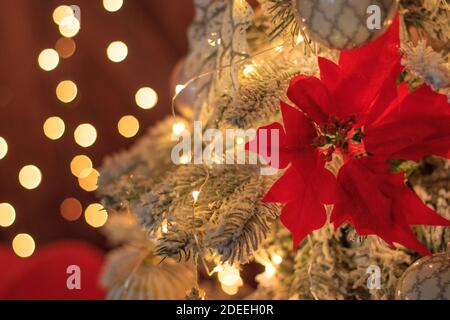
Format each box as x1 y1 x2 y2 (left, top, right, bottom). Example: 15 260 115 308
0 0 194 252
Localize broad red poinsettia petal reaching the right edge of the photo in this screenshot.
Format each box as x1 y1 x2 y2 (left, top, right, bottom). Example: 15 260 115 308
364 85 450 160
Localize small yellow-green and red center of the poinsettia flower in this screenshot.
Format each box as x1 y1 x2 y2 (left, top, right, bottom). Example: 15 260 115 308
313 116 365 162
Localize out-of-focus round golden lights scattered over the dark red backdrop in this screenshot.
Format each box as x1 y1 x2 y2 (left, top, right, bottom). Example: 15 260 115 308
0 0 158 258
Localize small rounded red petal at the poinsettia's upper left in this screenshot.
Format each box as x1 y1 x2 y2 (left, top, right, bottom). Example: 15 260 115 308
287 75 331 125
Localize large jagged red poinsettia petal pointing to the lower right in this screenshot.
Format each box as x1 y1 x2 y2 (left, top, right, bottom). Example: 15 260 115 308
331 158 449 255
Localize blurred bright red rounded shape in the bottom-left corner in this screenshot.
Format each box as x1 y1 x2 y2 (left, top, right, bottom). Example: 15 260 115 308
0 241 105 300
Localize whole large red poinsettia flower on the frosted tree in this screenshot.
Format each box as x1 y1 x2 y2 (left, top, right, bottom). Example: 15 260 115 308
250 18 450 254
